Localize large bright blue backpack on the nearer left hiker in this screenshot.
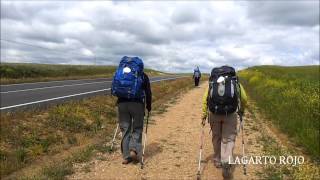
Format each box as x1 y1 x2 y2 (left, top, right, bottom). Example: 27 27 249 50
111 56 144 99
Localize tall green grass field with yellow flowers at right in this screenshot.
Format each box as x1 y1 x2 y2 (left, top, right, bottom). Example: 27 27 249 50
239 66 320 160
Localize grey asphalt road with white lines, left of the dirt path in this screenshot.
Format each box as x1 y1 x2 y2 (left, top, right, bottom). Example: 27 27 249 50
0 76 185 111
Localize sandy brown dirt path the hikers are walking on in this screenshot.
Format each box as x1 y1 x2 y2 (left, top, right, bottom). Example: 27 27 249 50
68 83 261 179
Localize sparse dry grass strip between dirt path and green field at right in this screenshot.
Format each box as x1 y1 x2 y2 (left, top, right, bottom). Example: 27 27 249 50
248 102 320 180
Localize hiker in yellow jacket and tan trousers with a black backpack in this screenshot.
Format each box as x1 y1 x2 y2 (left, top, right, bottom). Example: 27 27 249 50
202 66 247 179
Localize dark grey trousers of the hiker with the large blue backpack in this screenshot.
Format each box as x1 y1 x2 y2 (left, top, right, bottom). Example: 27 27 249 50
118 102 144 159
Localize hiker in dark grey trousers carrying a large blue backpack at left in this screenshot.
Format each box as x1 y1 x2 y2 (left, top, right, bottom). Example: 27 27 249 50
111 56 152 164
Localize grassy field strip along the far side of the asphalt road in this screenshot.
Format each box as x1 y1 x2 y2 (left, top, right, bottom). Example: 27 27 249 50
0 63 165 84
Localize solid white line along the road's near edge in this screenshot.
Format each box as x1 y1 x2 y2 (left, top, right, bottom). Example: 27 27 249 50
0 76 187 110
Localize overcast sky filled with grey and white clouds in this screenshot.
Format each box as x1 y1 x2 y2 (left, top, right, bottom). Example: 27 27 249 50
1 0 319 72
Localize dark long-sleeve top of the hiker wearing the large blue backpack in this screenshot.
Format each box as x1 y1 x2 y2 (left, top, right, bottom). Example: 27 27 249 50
118 73 152 111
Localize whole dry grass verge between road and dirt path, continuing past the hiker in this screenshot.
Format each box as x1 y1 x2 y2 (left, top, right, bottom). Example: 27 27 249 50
0 78 193 179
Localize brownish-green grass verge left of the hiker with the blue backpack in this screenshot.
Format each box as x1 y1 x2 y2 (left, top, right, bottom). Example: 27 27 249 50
0 96 116 176
